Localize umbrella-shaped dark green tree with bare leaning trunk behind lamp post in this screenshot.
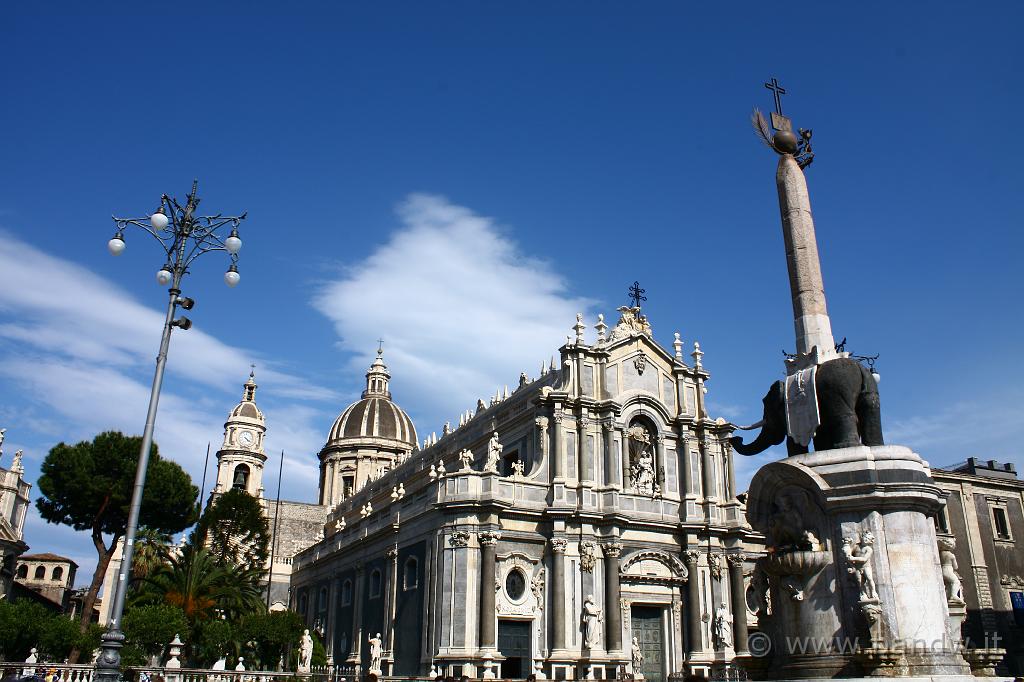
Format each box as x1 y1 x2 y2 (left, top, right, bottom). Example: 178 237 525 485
36 431 199 633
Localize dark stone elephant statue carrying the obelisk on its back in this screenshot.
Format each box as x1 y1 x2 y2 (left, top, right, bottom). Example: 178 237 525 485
729 357 885 455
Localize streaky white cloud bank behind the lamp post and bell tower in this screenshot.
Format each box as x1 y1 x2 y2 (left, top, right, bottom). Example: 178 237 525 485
0 231 338 585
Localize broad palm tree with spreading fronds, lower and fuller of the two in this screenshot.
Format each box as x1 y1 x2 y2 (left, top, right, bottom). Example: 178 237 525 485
132 543 264 627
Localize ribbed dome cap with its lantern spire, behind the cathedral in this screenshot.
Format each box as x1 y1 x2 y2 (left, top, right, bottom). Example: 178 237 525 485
325 349 417 450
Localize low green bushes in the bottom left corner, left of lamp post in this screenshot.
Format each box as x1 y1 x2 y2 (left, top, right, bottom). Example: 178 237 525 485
0 599 98 660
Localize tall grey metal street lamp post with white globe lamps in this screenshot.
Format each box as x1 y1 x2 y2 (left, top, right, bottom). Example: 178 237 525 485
95 180 246 682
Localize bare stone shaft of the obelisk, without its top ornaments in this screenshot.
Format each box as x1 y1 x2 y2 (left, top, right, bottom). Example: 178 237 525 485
775 154 836 360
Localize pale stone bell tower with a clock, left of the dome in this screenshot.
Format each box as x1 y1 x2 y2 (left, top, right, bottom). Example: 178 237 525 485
214 371 266 498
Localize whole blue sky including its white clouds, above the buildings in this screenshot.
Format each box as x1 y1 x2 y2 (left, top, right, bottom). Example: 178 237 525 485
0 2 1024 581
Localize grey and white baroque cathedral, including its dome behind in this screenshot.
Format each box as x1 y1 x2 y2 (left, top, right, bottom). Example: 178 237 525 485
291 306 759 680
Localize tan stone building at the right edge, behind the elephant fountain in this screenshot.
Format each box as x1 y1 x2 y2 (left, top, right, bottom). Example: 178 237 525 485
932 458 1024 677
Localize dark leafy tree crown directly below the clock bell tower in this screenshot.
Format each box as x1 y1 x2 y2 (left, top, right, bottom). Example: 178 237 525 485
191 488 270 573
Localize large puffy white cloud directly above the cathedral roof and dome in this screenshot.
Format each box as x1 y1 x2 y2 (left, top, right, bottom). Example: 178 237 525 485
313 195 591 434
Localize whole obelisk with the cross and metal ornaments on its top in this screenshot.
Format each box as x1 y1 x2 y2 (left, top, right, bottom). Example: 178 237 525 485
754 78 838 373
